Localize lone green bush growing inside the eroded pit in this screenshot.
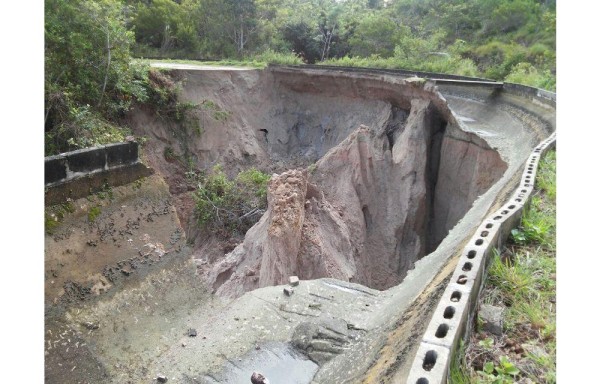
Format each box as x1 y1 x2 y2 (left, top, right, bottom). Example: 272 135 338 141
194 165 270 236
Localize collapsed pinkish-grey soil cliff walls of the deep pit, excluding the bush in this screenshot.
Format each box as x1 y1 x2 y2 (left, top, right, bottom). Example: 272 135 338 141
124 70 506 297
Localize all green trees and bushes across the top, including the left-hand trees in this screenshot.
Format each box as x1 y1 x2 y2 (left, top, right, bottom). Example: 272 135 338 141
44 0 556 155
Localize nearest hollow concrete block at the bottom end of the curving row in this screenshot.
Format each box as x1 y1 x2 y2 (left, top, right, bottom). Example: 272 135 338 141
406 342 450 384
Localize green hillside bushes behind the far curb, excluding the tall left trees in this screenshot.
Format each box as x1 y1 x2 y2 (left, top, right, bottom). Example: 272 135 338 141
129 0 556 89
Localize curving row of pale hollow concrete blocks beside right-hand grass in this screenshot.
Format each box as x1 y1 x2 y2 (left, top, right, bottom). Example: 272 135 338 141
407 133 556 384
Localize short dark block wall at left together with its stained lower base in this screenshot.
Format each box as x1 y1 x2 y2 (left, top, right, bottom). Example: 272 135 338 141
44 141 153 205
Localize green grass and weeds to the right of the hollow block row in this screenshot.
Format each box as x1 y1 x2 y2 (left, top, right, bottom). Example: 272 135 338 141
451 151 556 383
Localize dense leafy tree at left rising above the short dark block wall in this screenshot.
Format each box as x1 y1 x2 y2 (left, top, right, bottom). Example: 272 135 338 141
44 0 143 152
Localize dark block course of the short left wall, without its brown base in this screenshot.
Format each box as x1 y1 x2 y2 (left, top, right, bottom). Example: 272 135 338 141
44 141 139 187
